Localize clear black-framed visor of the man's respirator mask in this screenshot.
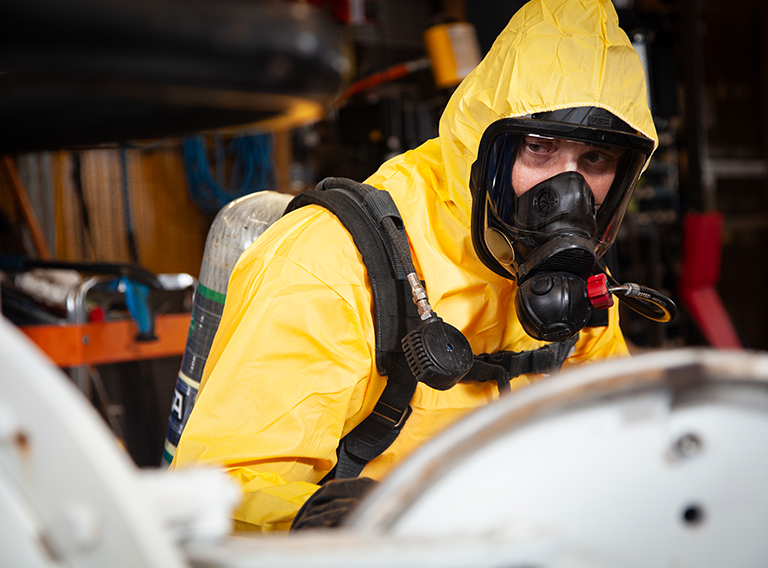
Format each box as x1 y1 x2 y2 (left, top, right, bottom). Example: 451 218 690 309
471 119 653 279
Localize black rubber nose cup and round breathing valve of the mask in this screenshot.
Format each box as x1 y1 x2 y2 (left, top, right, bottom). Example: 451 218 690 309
514 172 597 342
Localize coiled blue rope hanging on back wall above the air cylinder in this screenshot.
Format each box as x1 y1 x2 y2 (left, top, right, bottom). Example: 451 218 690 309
181 134 276 215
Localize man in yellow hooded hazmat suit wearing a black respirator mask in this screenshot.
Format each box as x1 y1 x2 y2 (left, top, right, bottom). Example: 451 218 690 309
174 0 657 531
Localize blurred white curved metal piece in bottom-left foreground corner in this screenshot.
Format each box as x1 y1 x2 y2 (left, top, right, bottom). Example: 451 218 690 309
0 319 187 568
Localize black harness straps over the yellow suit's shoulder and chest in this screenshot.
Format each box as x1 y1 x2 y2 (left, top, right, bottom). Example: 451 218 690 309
286 178 576 483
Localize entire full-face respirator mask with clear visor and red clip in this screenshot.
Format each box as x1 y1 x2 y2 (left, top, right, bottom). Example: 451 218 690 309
470 107 675 342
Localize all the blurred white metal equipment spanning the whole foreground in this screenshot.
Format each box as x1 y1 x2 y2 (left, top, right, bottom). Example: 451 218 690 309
0 316 768 568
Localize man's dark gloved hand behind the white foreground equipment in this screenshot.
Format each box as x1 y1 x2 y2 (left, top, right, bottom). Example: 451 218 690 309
291 477 378 531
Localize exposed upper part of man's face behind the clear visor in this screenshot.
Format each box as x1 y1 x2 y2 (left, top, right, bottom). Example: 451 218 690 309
512 134 623 207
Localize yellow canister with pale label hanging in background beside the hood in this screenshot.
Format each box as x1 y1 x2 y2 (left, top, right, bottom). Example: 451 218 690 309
424 22 482 89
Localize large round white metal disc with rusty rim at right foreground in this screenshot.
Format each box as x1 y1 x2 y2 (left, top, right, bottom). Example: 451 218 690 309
349 351 768 567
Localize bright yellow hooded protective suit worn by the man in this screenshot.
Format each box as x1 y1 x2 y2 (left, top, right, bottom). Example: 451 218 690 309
174 0 656 530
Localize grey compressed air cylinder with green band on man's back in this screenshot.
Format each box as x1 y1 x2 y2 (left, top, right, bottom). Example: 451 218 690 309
163 191 291 465
